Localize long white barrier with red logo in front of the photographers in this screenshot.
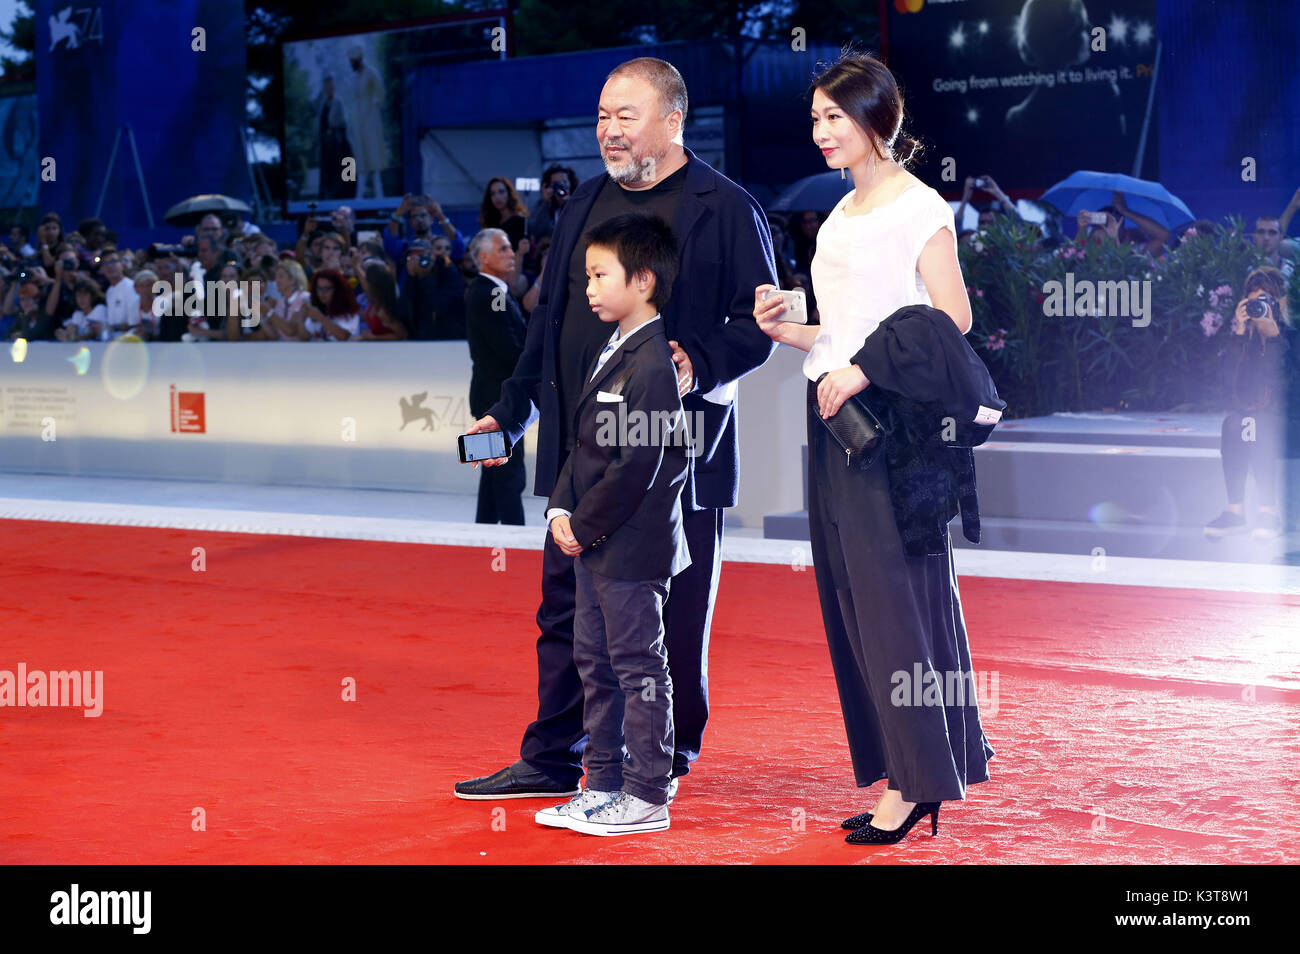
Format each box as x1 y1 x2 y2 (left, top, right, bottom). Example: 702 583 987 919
0 341 536 493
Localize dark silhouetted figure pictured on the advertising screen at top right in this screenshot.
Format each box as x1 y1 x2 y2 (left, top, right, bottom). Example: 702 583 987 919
1006 0 1128 163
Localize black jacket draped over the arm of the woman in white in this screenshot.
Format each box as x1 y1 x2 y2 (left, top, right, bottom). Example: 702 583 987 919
852 304 1006 556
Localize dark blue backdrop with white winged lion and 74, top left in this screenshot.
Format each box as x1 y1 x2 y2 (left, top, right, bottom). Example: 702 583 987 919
34 0 251 230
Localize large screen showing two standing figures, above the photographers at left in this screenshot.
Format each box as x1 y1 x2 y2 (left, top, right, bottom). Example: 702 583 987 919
282 14 504 212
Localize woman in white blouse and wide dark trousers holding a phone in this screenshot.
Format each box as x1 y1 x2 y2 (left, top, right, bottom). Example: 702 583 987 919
754 56 993 845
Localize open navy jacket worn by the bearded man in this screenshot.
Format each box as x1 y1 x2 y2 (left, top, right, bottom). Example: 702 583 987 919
488 149 776 509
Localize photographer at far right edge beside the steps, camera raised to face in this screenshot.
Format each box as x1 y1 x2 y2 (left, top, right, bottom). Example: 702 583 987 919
1205 266 1300 539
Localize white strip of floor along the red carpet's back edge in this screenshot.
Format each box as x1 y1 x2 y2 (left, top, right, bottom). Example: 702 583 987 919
0 473 1300 595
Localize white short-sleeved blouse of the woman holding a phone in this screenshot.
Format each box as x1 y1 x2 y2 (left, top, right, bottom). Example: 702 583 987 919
803 185 957 381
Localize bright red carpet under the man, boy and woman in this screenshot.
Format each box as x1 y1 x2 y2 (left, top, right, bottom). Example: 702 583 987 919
0 521 1300 864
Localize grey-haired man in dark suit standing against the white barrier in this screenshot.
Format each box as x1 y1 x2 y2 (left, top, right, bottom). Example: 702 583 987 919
465 229 528 526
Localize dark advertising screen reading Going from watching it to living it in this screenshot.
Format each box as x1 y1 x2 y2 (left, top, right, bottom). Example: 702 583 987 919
887 0 1157 191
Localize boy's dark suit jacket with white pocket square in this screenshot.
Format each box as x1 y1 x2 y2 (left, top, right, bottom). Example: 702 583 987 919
547 318 690 580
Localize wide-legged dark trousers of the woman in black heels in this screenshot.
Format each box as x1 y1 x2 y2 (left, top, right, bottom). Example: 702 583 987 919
807 382 996 802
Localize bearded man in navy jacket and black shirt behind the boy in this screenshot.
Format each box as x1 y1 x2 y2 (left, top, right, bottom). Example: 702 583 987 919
456 57 776 799
